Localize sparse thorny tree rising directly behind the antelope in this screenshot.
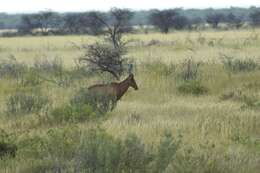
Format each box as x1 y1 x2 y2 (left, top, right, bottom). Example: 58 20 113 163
80 8 133 80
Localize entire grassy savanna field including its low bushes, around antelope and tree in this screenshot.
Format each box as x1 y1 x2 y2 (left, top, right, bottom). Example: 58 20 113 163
0 30 260 173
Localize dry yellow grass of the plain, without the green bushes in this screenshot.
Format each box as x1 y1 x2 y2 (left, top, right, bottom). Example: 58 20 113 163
0 30 260 172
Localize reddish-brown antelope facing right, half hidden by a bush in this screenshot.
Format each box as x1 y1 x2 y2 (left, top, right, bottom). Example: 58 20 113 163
88 74 138 100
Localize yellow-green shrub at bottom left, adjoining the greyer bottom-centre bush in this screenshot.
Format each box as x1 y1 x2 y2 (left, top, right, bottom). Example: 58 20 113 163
19 126 81 173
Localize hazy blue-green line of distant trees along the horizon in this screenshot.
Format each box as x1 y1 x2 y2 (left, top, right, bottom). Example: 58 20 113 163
0 7 260 35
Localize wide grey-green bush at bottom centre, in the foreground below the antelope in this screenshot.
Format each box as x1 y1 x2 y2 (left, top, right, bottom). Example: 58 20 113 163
76 129 181 173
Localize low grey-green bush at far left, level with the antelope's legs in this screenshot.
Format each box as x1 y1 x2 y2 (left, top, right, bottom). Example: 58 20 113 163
6 91 49 115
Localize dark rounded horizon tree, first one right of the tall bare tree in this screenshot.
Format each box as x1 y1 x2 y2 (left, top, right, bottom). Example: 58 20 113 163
149 10 178 34
